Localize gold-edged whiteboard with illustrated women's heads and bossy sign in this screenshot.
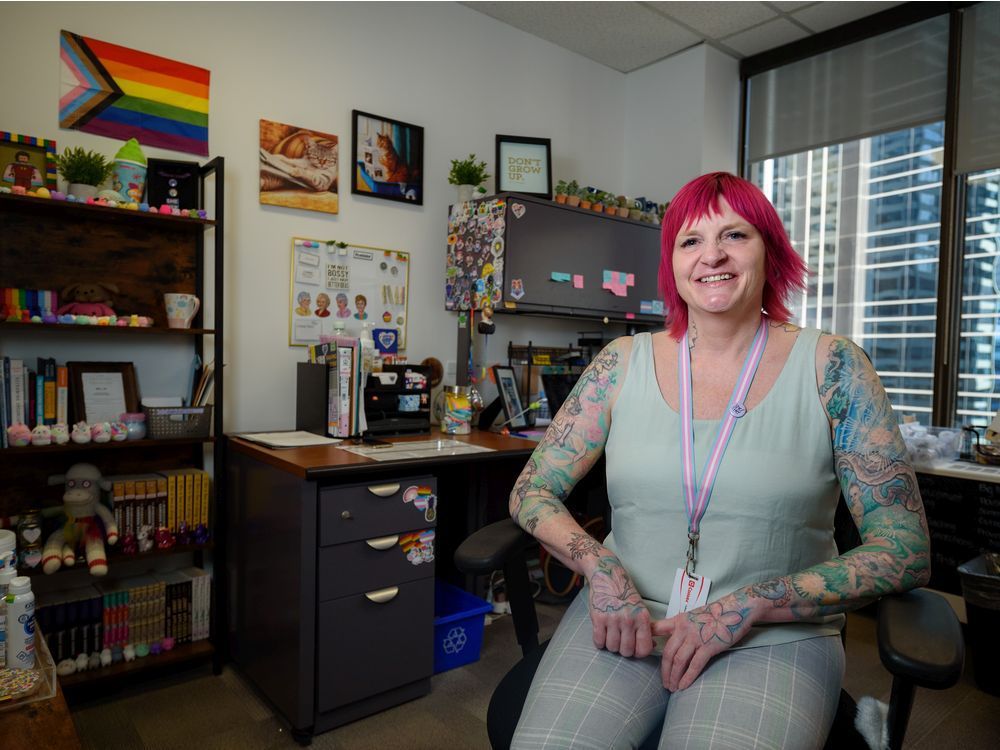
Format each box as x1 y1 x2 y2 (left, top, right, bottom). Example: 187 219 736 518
288 237 410 350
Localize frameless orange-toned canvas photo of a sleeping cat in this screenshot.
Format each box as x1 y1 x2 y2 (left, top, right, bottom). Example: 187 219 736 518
260 120 340 214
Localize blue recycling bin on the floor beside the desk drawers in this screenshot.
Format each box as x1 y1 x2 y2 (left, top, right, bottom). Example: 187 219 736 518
434 581 492 674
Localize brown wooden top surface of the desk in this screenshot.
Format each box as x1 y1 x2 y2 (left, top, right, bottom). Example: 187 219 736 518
227 430 538 480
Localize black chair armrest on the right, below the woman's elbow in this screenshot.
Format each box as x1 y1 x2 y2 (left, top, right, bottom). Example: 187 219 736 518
878 589 965 690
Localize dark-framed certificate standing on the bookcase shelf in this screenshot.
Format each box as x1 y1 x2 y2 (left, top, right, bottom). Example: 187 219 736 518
66 362 139 424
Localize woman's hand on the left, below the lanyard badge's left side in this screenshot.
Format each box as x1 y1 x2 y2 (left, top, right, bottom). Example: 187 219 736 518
587 554 653 659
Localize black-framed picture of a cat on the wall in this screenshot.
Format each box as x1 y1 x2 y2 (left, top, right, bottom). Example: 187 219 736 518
351 110 424 206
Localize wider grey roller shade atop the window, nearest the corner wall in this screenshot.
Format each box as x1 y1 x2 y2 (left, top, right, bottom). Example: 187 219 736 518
747 15 948 162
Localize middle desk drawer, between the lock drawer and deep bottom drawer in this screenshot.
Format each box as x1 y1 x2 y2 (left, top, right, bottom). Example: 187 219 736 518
317 529 434 602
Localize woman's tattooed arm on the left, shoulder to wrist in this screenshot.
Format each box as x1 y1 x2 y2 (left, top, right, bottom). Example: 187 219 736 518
510 340 627 571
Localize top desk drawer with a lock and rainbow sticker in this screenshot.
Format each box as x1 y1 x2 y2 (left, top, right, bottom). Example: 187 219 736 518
319 477 437 546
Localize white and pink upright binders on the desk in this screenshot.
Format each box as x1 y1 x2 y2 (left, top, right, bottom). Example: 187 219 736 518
309 336 367 438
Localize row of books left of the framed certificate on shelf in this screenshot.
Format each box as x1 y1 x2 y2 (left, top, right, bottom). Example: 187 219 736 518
0 357 69 448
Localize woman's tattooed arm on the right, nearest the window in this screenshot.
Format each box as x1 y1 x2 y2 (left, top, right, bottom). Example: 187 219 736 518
742 338 930 622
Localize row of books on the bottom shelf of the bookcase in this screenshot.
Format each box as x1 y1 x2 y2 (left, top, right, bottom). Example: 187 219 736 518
36 568 212 662
